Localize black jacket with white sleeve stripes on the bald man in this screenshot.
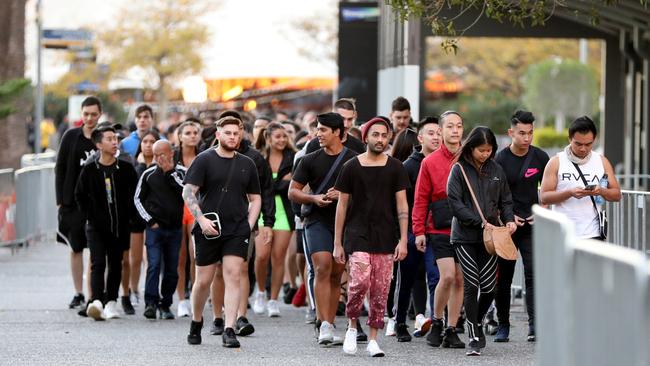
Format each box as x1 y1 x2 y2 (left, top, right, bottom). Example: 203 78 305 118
133 165 185 229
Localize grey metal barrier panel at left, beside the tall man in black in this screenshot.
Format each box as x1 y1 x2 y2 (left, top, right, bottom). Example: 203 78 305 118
15 163 58 243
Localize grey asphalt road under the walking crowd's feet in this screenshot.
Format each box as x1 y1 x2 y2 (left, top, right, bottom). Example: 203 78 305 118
0 244 535 366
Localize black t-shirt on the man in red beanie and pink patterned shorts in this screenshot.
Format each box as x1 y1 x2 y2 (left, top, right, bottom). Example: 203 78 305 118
335 157 410 254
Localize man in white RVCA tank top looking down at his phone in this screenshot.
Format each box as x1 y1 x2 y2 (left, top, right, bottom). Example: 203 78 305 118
540 116 621 239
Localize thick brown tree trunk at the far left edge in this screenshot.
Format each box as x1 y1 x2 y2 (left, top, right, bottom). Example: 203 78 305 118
0 0 29 168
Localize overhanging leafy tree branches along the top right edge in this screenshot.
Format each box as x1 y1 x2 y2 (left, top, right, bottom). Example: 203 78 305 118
385 0 648 53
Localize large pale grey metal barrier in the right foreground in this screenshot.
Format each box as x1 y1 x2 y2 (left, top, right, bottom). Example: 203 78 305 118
533 206 650 366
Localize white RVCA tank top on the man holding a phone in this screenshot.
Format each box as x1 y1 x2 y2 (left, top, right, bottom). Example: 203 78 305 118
552 151 605 239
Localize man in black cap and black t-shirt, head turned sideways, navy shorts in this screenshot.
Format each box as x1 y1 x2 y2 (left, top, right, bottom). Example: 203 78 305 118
289 113 356 345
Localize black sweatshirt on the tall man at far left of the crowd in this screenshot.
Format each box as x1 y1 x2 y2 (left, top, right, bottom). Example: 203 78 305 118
54 127 95 206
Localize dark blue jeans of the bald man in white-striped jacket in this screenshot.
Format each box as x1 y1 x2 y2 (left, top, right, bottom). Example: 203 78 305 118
144 228 182 307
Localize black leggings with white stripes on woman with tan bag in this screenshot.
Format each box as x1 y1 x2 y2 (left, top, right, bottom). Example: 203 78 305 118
454 242 497 339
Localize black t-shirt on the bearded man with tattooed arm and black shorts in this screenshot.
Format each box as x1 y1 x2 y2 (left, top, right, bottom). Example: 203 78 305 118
184 149 260 236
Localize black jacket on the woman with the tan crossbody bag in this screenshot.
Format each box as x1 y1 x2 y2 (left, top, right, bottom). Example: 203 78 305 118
447 159 514 243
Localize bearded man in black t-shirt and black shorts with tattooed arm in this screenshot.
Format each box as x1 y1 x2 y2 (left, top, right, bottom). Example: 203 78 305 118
183 116 262 348
